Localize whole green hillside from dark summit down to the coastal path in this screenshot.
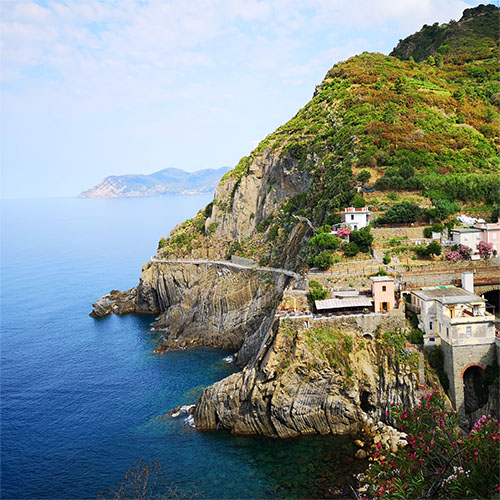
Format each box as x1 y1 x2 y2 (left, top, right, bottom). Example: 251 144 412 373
158 6 500 265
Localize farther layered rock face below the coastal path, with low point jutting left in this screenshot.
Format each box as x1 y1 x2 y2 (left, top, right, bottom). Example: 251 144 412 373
92 262 290 365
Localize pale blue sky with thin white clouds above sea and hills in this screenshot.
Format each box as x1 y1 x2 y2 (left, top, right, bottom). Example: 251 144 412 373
0 0 487 198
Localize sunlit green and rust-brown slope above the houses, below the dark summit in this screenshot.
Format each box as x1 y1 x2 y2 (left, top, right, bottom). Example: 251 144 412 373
227 6 500 212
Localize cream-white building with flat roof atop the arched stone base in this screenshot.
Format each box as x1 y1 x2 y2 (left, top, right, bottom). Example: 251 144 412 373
408 273 495 346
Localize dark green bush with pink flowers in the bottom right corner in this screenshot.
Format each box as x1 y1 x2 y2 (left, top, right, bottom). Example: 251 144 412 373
363 392 500 500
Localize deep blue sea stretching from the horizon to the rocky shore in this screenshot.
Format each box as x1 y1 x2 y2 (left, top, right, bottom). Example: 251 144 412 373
0 196 355 499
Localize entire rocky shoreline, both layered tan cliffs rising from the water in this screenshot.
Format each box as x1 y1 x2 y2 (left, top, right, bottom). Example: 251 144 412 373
92 263 418 438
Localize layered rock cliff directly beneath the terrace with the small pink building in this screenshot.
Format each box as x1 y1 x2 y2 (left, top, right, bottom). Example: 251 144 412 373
194 319 418 438
